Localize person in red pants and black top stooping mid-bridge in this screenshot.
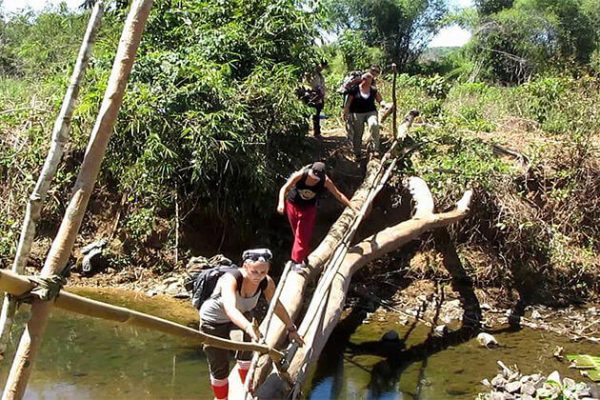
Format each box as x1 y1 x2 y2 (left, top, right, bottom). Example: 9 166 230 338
277 162 356 271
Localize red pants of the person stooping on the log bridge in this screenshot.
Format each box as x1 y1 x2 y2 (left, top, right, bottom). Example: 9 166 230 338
285 200 317 263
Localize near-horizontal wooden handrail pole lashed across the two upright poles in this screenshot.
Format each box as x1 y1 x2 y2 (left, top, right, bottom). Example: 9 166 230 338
0 270 283 361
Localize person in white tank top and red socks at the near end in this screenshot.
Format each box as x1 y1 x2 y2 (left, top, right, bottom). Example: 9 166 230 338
200 249 304 400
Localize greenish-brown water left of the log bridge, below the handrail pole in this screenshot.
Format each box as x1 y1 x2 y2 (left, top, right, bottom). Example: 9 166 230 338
0 310 212 399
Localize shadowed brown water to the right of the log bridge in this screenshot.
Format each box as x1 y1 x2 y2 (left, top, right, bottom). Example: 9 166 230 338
306 313 598 400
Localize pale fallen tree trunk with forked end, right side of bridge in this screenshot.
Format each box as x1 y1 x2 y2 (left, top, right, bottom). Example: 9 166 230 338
257 178 472 399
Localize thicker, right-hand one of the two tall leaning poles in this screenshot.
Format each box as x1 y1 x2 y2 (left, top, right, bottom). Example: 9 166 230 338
2 0 152 400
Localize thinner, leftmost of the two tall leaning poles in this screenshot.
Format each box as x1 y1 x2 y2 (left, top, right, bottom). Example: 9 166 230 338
0 0 104 360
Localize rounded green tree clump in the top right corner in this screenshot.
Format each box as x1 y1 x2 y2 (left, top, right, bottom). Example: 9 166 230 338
471 0 599 83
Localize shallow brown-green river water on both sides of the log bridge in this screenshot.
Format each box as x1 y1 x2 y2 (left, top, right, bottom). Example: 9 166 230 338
0 290 600 400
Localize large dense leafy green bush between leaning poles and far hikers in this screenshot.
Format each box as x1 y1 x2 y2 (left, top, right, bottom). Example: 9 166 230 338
92 0 317 244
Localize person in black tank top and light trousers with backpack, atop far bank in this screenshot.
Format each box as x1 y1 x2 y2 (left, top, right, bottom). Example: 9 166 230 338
342 68 383 158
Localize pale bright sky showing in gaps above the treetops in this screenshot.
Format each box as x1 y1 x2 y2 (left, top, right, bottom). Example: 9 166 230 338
0 0 473 47
